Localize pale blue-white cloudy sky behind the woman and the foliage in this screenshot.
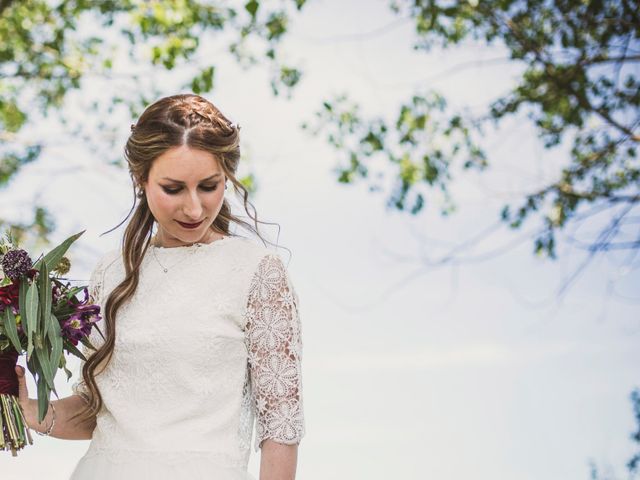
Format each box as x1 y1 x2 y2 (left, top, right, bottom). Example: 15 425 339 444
0 0 640 480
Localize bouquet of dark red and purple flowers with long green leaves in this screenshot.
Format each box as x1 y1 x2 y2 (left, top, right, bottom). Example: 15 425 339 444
0 231 104 456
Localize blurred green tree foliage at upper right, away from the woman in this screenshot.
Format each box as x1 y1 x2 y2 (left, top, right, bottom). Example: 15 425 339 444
304 0 640 258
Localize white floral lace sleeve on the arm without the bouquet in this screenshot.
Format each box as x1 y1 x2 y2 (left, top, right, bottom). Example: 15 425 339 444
245 253 305 452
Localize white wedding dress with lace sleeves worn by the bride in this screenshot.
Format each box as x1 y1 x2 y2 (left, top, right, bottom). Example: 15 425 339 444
70 237 305 480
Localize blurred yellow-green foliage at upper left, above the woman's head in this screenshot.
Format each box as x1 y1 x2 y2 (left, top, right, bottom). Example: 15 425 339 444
0 0 305 240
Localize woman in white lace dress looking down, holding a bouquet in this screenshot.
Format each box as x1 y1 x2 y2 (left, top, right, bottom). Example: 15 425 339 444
16 95 305 480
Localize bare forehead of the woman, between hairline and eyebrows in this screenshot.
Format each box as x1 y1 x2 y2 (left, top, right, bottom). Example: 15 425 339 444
149 145 222 181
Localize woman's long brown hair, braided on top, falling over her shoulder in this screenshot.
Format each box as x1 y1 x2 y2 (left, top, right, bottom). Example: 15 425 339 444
71 94 278 422
